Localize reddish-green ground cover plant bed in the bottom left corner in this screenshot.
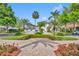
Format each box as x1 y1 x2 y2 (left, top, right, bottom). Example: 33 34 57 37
0 44 21 56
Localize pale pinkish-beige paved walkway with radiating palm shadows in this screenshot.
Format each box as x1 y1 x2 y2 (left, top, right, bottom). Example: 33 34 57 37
0 38 79 56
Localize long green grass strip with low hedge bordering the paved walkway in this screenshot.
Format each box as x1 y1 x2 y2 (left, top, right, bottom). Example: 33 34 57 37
0 34 79 41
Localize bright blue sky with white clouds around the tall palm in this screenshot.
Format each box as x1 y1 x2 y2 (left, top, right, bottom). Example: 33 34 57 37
9 3 70 24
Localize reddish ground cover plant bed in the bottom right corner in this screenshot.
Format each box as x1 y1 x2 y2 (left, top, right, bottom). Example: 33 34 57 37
54 43 79 56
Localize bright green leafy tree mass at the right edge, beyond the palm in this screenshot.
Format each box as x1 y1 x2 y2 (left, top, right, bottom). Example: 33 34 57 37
59 3 79 30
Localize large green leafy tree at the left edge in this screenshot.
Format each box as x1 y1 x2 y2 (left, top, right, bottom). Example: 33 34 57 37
0 3 16 31
